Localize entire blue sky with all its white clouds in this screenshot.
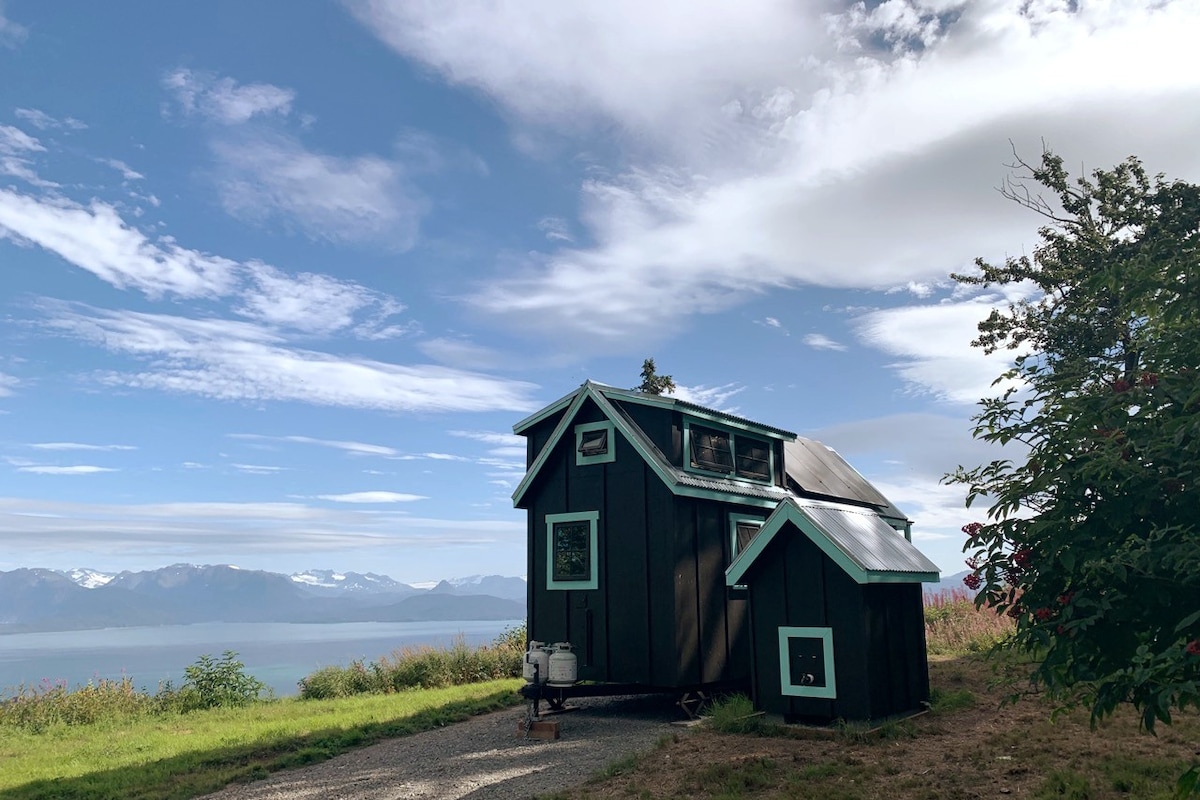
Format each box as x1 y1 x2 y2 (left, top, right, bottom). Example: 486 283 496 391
0 0 1200 582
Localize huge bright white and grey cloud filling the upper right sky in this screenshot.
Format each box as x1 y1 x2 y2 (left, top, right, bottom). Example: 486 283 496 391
362 0 1200 349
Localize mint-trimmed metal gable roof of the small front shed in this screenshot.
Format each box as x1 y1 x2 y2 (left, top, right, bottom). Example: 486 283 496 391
725 497 938 587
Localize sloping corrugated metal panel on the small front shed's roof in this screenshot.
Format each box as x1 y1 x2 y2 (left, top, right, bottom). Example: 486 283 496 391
793 500 938 573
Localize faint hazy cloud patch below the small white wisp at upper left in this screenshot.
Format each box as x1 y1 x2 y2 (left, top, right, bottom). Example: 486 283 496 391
212 131 426 251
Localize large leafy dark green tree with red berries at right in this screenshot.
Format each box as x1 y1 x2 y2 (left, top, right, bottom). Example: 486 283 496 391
947 146 1200 743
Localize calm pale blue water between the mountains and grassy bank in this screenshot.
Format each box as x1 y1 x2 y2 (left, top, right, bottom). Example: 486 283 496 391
0 620 522 697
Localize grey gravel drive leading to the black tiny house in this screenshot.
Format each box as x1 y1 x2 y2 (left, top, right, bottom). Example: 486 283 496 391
195 696 684 800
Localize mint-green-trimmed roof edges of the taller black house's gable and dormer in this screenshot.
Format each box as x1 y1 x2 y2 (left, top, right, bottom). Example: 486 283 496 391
512 380 796 509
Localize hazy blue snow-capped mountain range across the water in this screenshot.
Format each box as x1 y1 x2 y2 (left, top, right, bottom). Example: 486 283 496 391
0 564 526 633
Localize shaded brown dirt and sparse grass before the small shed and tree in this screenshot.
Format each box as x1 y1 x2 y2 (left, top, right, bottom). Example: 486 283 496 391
556 658 1200 800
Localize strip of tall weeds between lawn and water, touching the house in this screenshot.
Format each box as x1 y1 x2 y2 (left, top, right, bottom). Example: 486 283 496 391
299 626 524 699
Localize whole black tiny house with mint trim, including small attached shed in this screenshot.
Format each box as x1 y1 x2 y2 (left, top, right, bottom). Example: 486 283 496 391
512 381 937 721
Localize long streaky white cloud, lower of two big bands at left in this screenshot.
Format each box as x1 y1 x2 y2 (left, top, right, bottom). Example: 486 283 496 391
46 303 534 411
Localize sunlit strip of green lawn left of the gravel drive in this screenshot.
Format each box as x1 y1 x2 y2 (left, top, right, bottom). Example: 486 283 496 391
0 679 522 800
